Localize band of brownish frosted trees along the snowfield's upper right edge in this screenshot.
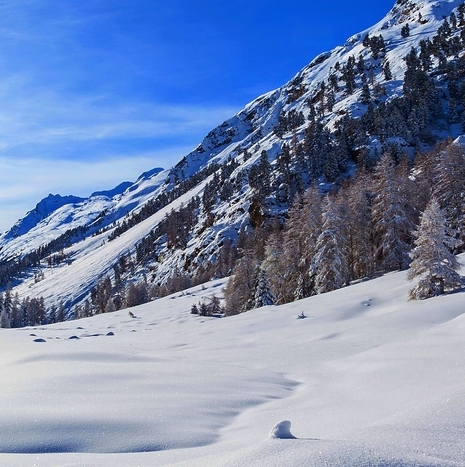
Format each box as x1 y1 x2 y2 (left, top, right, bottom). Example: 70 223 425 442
225 141 465 315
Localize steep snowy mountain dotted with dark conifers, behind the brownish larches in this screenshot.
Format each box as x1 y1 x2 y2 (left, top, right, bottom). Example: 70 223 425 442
0 0 465 318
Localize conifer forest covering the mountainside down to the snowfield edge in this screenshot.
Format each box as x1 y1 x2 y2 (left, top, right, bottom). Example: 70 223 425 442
0 3 465 327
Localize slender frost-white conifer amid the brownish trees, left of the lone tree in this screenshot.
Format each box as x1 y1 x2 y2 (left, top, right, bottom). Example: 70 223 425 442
310 195 349 293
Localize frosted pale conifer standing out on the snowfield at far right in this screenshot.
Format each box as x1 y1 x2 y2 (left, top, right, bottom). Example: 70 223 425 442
407 198 462 300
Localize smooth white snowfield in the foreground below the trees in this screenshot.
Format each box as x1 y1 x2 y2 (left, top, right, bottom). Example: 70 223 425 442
0 256 465 467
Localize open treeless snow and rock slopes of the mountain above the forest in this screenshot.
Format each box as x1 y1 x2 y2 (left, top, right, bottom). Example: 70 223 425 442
0 0 461 314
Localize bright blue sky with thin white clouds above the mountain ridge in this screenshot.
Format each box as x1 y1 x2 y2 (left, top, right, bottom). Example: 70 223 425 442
0 0 394 231
